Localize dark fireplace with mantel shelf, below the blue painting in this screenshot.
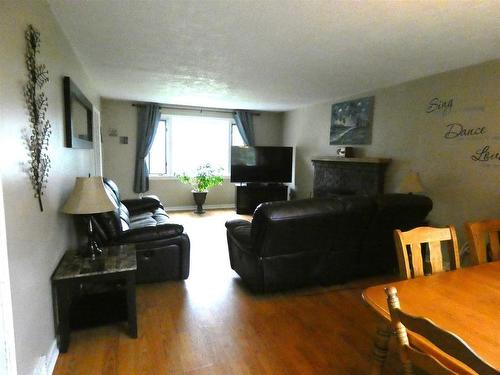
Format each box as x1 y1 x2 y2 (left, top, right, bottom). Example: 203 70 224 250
312 157 391 198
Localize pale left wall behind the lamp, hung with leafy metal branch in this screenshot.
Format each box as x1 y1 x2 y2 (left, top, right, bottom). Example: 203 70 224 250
0 0 99 375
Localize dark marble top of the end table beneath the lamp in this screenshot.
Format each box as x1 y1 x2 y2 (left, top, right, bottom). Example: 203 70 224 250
52 245 137 281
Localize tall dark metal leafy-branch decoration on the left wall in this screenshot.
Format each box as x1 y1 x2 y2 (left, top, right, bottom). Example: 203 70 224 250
24 25 52 212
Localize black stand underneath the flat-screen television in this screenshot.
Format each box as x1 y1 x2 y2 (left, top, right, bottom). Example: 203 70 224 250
236 183 288 215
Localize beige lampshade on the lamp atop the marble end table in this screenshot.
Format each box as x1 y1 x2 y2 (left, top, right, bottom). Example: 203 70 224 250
62 176 116 215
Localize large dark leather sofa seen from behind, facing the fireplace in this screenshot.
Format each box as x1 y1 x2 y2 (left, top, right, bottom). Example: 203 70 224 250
226 194 432 292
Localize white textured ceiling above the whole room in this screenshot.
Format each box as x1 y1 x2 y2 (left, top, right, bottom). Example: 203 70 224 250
48 0 500 110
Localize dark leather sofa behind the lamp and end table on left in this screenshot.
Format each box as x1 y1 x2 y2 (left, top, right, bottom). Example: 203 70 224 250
92 178 190 283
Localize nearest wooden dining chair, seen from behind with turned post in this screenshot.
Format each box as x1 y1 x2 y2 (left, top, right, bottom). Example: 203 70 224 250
385 287 499 375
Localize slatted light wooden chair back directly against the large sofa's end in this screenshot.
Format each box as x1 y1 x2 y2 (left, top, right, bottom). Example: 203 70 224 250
394 225 460 279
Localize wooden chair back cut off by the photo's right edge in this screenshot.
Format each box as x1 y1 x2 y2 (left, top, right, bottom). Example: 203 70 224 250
465 219 500 264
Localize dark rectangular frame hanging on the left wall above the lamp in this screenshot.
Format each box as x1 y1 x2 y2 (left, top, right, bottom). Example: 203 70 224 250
63 76 94 149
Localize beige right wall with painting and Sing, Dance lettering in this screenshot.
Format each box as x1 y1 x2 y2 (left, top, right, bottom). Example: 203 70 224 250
284 60 500 238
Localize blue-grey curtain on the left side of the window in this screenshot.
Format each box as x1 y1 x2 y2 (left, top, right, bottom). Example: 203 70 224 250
134 103 160 193
